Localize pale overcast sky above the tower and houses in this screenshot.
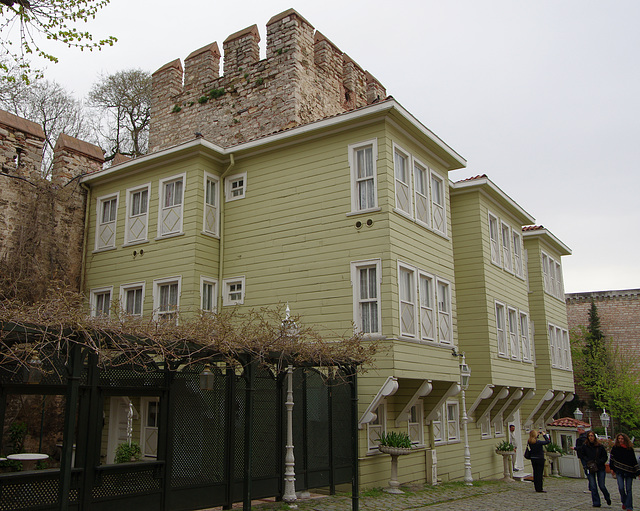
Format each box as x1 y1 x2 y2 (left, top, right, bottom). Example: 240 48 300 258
28 0 640 292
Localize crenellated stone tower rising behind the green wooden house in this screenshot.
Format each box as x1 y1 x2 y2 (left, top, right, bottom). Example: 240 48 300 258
149 9 386 152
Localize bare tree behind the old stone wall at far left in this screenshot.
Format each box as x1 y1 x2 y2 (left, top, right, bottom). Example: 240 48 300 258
0 80 91 177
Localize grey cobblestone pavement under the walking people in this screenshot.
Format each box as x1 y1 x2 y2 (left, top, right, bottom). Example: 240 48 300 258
238 476 640 511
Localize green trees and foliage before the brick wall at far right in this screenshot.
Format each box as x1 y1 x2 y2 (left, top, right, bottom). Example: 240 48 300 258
571 301 640 438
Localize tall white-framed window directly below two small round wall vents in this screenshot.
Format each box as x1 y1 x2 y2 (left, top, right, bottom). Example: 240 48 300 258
351 260 381 334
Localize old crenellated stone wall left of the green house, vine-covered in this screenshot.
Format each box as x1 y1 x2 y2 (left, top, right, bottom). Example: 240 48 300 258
0 111 104 300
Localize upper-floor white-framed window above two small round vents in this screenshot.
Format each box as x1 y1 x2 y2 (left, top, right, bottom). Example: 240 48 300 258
349 139 378 212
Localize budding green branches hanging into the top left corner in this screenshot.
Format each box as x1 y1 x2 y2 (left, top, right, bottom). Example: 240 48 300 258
0 0 117 83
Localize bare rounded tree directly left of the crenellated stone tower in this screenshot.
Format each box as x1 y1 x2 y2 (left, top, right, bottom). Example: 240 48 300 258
89 69 151 161
